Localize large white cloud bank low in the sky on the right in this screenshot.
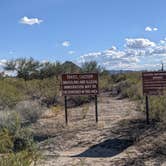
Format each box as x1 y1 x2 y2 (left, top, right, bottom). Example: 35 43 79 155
78 38 166 70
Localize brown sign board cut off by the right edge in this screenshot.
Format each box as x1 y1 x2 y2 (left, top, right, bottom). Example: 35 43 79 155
142 71 166 95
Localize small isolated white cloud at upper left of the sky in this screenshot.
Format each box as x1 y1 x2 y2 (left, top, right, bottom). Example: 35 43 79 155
20 16 43 25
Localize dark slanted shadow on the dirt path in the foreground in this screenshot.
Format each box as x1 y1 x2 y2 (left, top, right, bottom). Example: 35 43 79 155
72 138 133 158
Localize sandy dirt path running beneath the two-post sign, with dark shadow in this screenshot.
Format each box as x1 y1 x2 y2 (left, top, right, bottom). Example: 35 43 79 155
34 95 165 166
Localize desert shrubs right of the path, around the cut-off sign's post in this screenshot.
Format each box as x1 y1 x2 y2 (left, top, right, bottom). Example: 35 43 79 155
112 72 166 122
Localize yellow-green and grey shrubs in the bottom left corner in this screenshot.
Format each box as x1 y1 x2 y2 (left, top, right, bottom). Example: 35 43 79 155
0 112 40 166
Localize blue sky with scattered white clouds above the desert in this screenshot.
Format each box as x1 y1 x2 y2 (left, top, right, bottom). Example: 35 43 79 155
0 0 166 70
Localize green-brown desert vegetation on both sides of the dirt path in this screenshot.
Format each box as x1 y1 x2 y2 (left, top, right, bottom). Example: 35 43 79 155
0 58 166 166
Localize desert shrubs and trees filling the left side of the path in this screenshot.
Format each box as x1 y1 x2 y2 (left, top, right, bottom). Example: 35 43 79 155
0 58 110 166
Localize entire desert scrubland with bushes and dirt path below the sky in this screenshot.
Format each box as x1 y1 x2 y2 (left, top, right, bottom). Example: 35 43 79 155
0 58 166 166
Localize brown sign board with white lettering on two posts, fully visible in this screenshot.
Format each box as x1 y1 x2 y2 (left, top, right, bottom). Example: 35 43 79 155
62 73 99 96
